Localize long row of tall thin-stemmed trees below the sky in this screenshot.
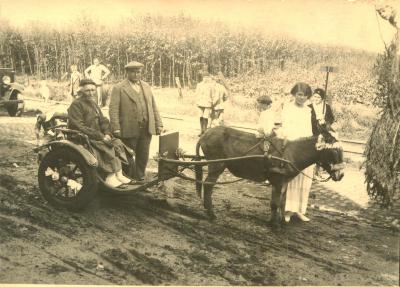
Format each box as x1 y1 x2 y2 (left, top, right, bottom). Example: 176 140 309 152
0 14 374 87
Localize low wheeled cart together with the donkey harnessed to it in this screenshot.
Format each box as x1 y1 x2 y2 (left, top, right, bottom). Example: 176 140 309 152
35 122 344 228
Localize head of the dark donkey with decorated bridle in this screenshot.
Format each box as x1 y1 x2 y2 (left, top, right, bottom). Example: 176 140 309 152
316 133 344 181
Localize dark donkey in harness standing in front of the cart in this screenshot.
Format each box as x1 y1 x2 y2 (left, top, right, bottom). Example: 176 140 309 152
195 126 344 227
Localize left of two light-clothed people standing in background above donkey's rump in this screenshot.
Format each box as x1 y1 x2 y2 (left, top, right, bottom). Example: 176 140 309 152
196 70 216 136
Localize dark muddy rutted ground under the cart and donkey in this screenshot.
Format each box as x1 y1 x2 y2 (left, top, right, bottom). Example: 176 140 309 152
0 105 399 285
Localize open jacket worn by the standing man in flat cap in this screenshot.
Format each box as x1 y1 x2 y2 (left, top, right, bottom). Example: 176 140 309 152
109 79 162 138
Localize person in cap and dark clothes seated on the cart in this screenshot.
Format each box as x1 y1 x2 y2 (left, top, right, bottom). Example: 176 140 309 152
68 79 131 187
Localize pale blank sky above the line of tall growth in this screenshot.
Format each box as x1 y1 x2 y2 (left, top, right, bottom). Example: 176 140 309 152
0 0 400 52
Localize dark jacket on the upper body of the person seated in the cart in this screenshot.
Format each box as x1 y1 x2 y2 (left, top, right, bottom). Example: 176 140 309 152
68 96 111 141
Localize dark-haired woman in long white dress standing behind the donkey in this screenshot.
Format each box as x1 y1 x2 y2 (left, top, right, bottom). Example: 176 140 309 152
281 83 314 222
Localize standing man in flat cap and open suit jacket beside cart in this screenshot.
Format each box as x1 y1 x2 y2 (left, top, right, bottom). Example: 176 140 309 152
109 61 163 181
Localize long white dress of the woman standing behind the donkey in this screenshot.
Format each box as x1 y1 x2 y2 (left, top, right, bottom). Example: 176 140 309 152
282 102 314 214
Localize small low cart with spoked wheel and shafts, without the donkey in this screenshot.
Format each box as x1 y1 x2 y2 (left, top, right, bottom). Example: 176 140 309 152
35 126 282 210
